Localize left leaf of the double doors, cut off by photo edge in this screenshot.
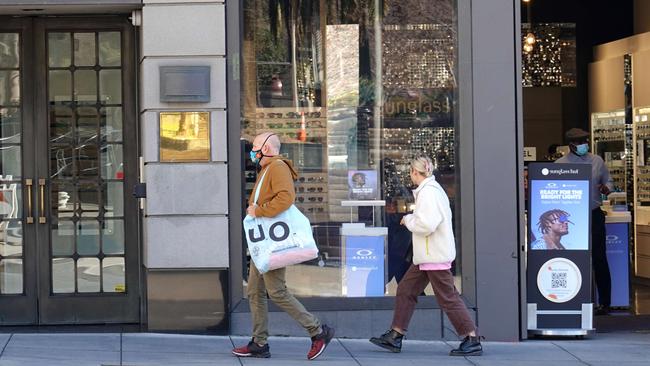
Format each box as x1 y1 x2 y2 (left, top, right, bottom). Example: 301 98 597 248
0 21 38 324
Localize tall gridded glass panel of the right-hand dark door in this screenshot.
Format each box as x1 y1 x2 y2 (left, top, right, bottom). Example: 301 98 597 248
45 32 125 293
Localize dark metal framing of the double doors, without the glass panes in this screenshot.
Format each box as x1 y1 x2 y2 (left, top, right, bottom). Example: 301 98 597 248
0 16 141 325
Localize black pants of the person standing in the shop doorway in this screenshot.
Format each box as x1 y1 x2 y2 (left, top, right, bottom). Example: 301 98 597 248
591 207 612 306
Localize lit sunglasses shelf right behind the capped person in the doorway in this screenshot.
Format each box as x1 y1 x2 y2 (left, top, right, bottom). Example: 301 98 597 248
591 111 627 192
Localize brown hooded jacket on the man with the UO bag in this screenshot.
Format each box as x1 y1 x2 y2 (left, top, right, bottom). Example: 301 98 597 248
248 156 298 217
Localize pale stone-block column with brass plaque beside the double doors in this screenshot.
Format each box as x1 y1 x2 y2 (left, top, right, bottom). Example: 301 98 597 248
139 0 229 331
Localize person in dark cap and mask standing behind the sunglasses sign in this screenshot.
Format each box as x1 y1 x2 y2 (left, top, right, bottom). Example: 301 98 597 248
555 128 612 315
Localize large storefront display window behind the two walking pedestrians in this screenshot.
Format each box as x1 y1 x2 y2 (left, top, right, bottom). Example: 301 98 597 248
241 0 461 297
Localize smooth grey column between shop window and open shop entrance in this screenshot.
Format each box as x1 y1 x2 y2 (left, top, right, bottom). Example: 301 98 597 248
471 0 524 341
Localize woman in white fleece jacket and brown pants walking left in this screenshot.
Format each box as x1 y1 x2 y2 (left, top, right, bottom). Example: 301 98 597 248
370 156 483 356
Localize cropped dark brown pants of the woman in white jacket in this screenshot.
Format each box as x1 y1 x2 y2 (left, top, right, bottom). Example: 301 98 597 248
392 264 476 337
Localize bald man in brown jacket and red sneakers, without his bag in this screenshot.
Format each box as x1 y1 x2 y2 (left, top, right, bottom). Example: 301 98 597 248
232 132 334 360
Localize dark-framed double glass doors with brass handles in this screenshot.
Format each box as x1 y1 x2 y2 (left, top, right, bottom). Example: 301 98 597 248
0 18 139 324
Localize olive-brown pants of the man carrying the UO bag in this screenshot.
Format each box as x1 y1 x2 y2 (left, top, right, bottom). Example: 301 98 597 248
248 261 321 344
